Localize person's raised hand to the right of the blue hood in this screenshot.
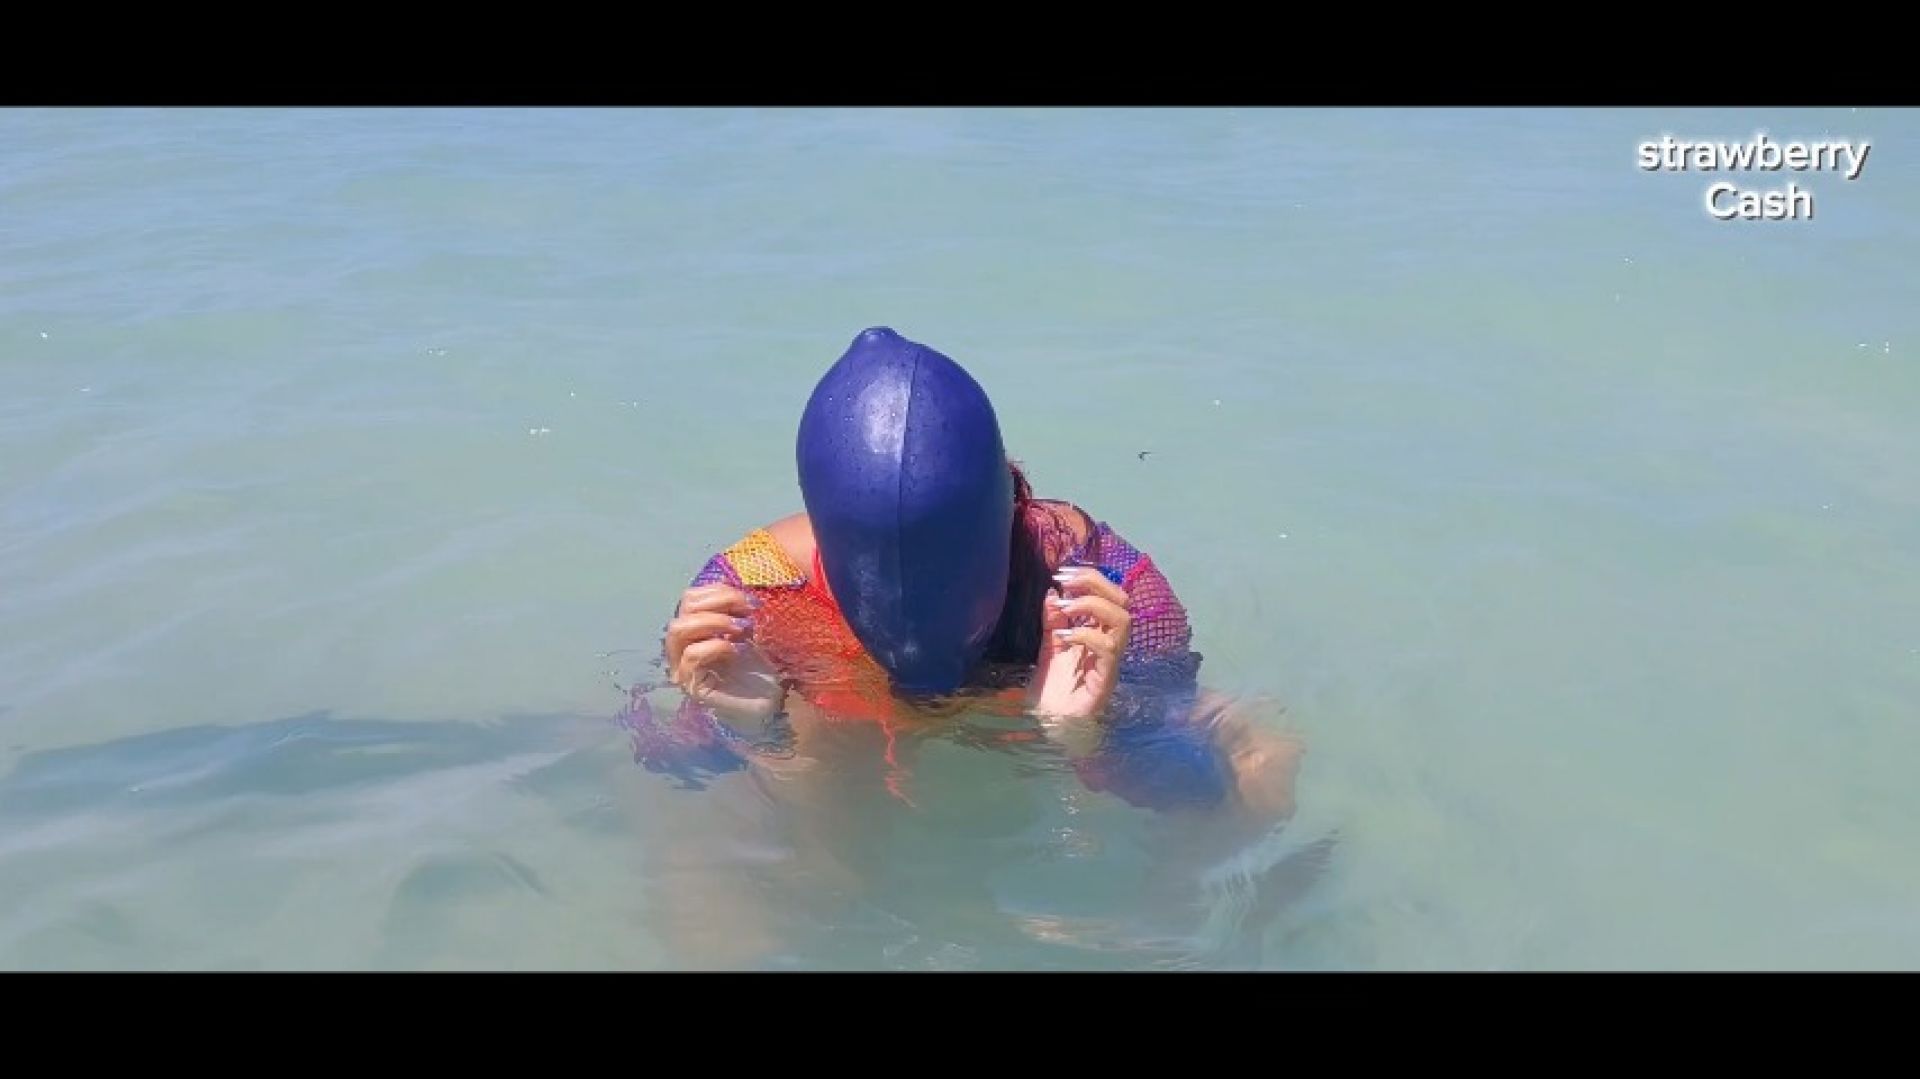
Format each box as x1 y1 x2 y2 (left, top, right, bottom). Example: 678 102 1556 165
1033 566 1133 720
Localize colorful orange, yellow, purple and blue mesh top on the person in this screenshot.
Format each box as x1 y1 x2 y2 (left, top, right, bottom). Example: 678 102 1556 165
622 503 1227 808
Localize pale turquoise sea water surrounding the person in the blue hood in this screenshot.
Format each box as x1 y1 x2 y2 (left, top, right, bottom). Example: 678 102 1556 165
0 109 1920 970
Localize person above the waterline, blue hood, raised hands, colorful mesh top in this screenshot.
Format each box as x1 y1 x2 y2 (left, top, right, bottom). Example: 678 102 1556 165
634 328 1300 822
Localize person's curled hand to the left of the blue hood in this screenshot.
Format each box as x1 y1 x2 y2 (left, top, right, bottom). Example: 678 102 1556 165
666 584 787 724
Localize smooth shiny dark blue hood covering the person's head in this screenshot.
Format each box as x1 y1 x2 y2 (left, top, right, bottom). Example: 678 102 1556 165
799 326 1014 693
